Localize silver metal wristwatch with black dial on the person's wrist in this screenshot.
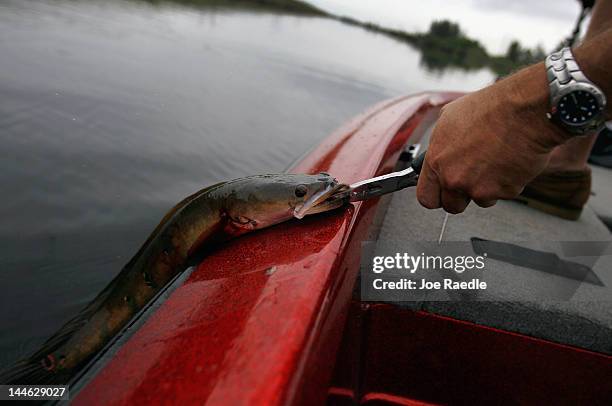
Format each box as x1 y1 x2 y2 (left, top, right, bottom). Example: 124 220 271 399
545 48 606 135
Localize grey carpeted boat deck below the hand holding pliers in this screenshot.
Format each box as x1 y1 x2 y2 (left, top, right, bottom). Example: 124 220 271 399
377 137 612 354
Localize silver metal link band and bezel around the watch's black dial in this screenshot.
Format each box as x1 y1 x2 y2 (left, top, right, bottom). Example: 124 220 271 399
544 48 606 135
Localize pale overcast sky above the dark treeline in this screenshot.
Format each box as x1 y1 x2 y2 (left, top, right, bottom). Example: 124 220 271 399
308 0 586 53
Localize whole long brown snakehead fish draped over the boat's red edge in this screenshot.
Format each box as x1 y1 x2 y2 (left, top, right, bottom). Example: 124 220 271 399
0 173 347 385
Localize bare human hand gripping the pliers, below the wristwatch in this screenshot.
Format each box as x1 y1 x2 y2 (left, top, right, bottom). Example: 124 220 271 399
417 64 568 213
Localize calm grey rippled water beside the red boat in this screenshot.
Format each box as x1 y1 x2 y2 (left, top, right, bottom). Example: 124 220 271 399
0 0 492 368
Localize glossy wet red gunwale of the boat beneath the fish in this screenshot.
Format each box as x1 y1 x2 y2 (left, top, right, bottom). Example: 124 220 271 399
74 93 460 405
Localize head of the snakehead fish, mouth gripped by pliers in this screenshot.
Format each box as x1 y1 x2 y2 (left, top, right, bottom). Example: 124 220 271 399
226 173 348 229
